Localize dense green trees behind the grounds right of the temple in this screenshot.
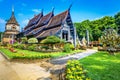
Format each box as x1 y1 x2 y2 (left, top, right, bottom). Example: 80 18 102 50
75 16 116 41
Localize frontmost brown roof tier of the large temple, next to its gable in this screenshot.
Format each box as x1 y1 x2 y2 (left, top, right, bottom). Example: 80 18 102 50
36 10 68 38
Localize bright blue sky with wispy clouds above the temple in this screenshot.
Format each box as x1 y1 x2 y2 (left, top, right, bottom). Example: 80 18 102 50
0 0 120 31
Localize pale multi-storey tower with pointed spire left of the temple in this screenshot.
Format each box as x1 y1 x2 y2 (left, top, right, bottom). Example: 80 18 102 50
2 8 20 43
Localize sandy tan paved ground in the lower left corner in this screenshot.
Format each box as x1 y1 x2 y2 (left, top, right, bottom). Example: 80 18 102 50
0 53 50 80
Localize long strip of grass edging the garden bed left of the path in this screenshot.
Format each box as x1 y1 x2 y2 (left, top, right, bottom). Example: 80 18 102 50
0 48 82 59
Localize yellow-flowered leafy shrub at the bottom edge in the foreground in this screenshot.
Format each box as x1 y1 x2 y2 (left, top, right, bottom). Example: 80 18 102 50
66 60 91 80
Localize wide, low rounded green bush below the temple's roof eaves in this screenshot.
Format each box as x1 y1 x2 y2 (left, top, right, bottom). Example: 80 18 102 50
41 36 60 44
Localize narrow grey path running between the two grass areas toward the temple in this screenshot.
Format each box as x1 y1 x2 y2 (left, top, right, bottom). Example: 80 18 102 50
50 49 97 65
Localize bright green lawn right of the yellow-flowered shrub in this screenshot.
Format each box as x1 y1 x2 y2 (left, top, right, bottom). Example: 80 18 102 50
79 52 120 80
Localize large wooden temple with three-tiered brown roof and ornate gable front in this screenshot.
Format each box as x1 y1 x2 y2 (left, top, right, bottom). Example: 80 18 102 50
19 8 76 45
